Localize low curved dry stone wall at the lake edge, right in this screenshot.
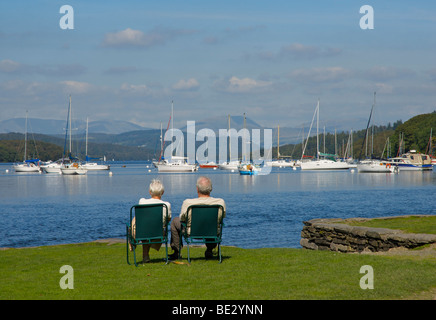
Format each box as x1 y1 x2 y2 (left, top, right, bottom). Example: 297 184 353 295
300 216 436 252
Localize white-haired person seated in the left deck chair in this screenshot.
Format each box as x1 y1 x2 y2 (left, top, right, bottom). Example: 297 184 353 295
130 179 171 263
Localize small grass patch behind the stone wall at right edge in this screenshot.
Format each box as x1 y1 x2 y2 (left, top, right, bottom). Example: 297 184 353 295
347 215 436 234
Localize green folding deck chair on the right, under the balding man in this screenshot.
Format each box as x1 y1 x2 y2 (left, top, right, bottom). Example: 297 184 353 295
179 205 224 263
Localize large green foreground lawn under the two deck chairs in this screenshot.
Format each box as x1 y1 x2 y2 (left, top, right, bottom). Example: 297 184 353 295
0 243 436 300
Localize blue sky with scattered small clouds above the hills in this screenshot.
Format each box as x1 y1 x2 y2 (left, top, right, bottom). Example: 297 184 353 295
0 0 436 129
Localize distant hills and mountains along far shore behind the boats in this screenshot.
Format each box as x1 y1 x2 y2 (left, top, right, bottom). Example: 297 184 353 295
0 112 430 162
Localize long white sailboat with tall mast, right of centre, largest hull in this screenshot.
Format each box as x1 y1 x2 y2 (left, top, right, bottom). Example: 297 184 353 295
300 100 349 170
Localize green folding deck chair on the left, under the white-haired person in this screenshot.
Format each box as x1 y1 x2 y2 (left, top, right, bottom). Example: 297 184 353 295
126 203 168 266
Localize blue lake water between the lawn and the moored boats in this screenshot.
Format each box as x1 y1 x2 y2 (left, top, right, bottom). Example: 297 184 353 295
0 162 436 248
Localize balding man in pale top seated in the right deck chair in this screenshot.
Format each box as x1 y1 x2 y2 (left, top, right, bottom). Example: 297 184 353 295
169 177 226 260
